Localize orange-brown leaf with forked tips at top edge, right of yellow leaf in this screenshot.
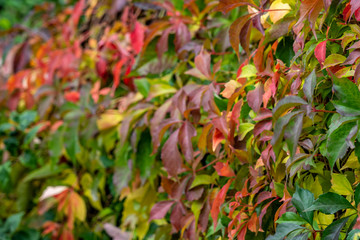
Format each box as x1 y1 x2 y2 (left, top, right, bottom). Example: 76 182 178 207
294 0 324 35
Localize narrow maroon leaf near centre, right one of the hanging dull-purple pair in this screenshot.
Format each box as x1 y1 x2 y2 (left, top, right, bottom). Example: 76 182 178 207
179 121 196 162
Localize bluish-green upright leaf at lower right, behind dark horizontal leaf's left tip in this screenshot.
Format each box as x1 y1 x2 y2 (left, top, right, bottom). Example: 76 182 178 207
291 186 314 225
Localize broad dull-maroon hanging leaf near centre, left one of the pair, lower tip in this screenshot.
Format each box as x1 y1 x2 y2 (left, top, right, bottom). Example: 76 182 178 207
161 130 182 177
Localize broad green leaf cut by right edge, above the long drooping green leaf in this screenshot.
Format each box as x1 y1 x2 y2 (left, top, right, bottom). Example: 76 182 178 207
333 76 360 116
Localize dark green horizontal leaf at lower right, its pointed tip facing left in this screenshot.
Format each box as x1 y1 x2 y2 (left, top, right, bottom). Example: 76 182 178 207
304 192 354 214
